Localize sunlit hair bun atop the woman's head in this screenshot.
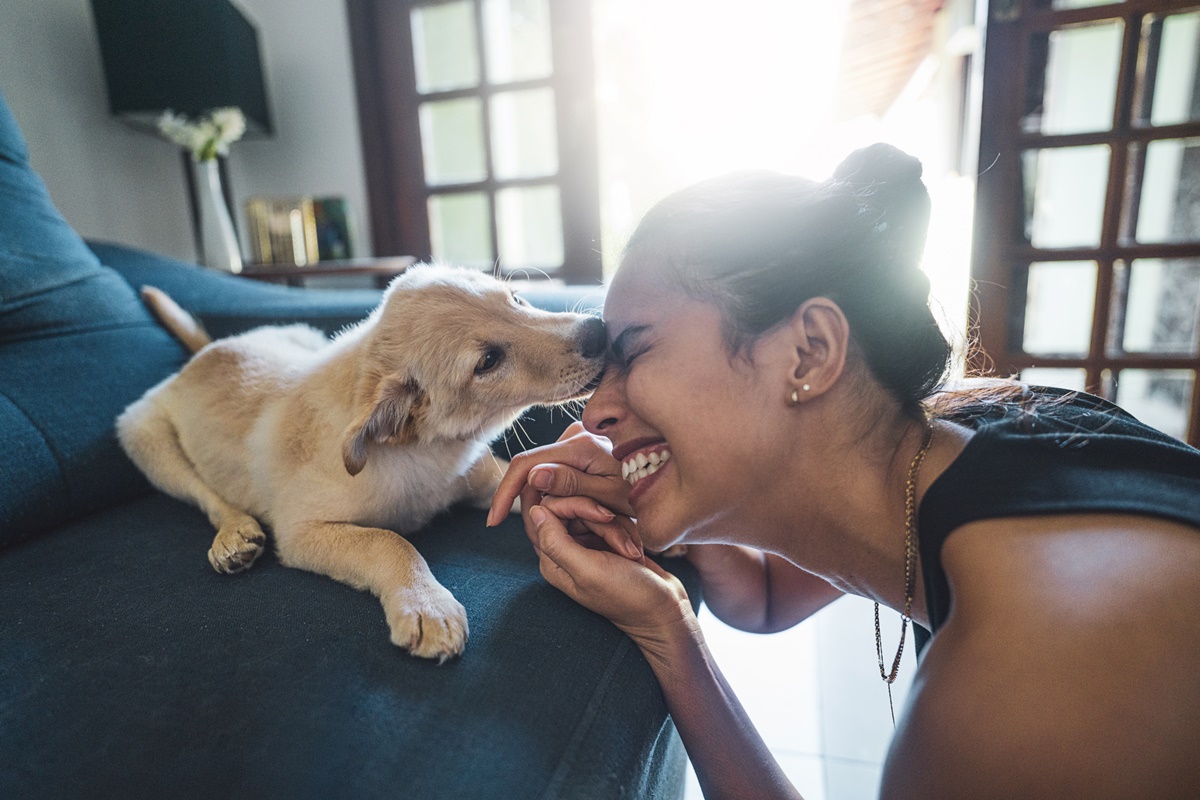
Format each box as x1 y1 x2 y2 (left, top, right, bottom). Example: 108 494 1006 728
833 143 930 267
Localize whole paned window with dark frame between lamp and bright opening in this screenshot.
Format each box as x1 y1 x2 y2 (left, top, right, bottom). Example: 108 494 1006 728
349 0 600 282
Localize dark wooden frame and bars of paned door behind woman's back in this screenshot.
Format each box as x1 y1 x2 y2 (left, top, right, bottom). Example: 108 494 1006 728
968 0 1200 445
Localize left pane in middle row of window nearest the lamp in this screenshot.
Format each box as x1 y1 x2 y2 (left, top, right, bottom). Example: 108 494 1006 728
420 97 487 186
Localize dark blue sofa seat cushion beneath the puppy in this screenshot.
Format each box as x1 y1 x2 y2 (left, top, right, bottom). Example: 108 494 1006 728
0 494 697 800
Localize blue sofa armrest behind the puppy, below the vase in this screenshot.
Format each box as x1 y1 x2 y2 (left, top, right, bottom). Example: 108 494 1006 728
88 241 382 338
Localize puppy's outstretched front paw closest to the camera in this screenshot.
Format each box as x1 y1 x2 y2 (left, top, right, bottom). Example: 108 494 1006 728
383 582 468 663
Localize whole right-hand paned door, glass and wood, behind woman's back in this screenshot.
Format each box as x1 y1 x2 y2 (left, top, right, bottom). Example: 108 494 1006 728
972 0 1200 445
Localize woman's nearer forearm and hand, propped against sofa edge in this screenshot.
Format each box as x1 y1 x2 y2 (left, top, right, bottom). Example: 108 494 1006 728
527 506 799 800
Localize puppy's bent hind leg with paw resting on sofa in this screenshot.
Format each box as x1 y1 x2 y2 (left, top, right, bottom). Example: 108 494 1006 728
116 397 266 575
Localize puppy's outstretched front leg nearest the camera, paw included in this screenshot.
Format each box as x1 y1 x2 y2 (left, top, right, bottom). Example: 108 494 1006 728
275 522 468 663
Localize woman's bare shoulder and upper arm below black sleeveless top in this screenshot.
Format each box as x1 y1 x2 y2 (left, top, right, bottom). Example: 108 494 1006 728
884 515 1200 798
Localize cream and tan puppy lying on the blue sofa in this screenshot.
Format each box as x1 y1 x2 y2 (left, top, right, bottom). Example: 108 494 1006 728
116 265 606 661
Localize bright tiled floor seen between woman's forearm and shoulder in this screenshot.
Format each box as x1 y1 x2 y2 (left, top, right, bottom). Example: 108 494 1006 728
684 597 916 800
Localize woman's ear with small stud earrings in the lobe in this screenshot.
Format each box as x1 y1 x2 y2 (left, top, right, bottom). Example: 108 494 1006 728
787 297 850 405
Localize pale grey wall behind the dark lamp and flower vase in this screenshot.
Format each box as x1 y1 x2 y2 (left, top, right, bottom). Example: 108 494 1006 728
0 0 370 259
